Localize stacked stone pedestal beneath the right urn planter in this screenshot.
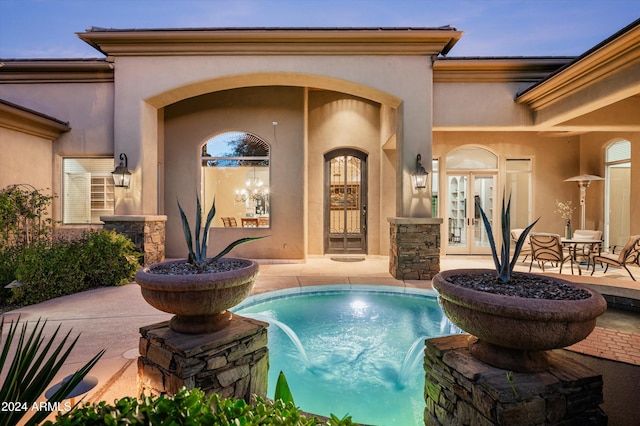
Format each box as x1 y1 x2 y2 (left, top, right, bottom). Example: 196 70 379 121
424 334 607 426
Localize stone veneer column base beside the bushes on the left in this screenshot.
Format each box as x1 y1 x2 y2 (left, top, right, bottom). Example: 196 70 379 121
100 215 167 266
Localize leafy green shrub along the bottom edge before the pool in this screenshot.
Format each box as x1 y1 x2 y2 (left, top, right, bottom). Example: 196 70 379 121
45 389 354 426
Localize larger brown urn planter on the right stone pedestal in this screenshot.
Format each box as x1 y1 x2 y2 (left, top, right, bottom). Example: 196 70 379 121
432 269 607 372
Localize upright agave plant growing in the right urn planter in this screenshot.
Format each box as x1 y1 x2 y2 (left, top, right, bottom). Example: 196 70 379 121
478 194 540 283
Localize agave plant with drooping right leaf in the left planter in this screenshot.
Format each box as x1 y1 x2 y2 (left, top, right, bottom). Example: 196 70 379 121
178 196 264 272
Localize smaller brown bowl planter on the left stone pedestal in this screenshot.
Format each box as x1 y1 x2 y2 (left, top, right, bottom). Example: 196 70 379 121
135 258 259 334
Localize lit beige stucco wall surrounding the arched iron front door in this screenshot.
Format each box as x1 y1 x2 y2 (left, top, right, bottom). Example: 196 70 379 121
308 91 382 255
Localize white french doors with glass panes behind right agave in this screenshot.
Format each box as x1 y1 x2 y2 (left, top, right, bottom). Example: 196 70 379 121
446 172 499 254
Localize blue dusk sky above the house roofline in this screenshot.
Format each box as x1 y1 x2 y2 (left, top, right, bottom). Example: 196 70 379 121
0 0 640 58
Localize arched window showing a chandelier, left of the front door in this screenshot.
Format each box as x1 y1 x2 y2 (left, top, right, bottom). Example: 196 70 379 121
201 132 270 227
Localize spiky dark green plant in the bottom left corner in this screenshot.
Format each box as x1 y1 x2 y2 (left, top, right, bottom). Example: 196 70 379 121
0 318 105 425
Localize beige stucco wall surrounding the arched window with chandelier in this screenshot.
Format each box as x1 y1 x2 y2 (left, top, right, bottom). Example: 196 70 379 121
160 87 305 259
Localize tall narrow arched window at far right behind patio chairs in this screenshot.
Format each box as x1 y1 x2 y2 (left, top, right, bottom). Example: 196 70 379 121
605 140 631 246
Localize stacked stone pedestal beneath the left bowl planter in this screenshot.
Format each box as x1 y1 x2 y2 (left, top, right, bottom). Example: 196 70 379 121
138 315 269 402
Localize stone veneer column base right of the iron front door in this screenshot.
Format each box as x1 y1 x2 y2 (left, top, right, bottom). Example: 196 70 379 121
387 217 442 280
